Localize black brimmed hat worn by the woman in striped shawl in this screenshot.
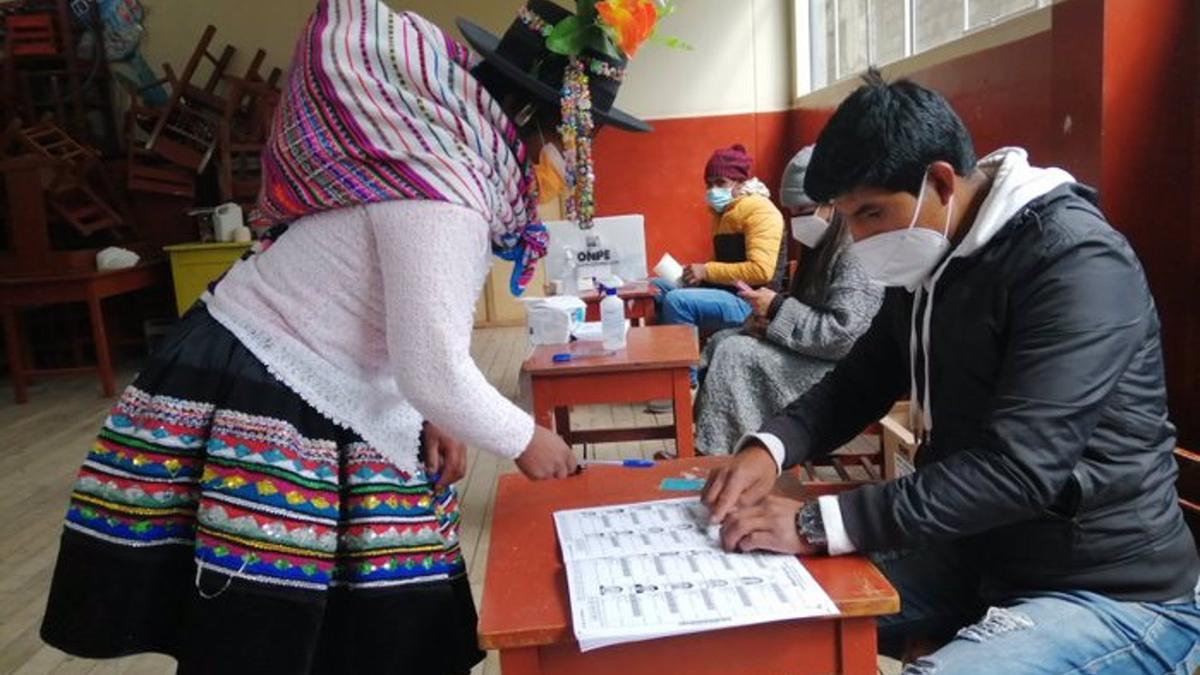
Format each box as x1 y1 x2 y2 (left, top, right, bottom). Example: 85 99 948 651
457 0 653 131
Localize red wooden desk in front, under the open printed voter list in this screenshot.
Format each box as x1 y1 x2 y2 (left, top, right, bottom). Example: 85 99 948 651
479 458 900 675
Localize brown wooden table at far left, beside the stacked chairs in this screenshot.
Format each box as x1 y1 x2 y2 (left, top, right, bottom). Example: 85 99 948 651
0 261 167 404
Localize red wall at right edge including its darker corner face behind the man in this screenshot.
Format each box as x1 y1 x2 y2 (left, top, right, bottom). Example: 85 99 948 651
1052 0 1200 448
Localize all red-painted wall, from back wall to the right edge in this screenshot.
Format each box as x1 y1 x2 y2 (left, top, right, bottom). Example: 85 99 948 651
595 0 1200 448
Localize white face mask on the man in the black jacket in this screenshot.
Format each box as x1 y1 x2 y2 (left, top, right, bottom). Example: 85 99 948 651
851 171 954 291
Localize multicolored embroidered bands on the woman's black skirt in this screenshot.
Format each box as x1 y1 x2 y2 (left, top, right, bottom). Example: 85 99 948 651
66 387 464 590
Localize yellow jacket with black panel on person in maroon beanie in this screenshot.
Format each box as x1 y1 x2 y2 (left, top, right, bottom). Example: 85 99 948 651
704 195 784 286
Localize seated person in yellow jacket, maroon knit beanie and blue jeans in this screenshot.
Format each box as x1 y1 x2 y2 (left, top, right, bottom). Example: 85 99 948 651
654 145 787 333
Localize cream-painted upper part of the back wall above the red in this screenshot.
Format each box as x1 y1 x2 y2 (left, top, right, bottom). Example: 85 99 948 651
143 0 806 119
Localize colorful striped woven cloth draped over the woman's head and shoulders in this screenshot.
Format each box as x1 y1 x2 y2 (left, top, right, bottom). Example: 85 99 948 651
258 0 547 294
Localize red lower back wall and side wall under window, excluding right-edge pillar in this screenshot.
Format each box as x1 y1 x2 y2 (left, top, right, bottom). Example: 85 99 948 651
595 32 1052 267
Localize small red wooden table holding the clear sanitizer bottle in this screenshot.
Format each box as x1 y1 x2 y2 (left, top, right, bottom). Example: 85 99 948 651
521 325 700 458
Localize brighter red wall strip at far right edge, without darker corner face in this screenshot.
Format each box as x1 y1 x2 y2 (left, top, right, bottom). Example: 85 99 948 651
1099 0 1200 448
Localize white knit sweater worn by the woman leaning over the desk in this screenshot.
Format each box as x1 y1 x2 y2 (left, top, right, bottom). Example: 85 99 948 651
205 201 534 473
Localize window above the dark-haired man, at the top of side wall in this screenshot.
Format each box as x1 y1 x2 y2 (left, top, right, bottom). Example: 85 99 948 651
796 0 1050 89
